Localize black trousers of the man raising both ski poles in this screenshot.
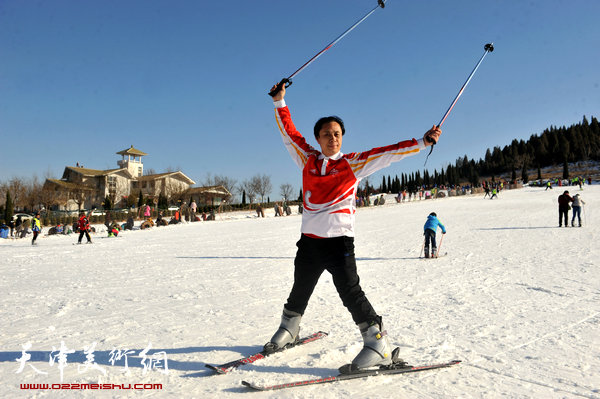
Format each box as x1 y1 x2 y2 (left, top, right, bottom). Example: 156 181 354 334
285 234 380 324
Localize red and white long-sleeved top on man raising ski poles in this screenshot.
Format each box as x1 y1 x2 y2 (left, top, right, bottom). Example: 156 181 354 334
274 100 425 238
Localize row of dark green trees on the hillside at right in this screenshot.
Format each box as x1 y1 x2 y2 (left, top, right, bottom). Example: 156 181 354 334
372 116 600 193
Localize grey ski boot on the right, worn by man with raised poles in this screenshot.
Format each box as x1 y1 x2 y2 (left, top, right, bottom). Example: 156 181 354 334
339 317 397 374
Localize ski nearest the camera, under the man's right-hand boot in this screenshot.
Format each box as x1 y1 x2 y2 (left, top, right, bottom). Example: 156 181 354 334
242 360 461 391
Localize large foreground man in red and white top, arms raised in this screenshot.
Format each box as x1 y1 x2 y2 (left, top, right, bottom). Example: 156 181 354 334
265 86 441 369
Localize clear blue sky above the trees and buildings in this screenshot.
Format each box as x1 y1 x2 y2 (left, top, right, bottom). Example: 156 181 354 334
0 0 600 199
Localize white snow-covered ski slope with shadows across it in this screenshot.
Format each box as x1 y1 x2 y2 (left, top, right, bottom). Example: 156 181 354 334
0 185 600 398
